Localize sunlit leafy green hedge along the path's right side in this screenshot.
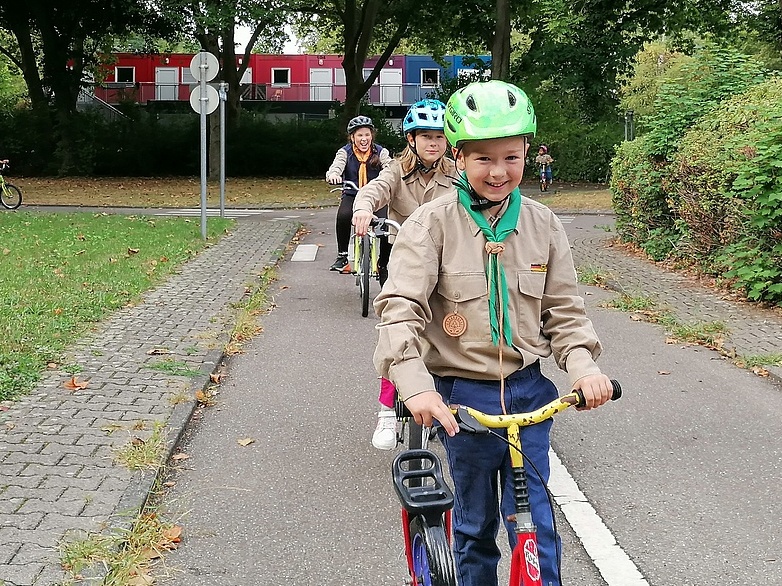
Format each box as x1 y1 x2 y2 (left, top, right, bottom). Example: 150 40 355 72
611 41 782 305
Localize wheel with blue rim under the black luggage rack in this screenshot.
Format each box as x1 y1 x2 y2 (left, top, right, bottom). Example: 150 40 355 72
410 516 456 586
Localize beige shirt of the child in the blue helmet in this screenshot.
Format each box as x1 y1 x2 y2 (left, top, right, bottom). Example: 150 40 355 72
353 158 459 224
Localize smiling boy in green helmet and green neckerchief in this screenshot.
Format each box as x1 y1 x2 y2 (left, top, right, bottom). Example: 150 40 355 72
374 80 612 586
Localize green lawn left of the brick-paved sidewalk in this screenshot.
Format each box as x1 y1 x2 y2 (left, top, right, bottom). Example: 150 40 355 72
0 212 233 400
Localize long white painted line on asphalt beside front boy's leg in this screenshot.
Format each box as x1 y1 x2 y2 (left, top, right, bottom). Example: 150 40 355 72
548 450 649 586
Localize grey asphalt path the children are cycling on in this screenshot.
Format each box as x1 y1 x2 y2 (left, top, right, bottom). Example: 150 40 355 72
160 210 782 586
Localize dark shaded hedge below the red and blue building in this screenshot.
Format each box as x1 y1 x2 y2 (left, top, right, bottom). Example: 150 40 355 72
0 107 404 177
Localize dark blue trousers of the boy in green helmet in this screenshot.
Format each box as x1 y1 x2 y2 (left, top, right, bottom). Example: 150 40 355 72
435 363 561 586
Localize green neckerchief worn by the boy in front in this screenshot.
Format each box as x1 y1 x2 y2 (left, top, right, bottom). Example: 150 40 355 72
456 176 521 346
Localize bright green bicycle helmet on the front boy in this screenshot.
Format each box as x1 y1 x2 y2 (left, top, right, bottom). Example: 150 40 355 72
445 79 537 148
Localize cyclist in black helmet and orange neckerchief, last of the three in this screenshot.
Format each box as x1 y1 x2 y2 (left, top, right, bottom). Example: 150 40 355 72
326 116 391 273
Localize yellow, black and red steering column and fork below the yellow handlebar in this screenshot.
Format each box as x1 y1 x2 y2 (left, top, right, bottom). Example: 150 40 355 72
508 423 543 586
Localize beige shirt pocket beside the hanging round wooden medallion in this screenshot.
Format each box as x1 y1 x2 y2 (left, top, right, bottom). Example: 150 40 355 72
433 273 491 342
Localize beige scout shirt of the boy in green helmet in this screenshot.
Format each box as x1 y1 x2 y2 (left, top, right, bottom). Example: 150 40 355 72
374 190 601 399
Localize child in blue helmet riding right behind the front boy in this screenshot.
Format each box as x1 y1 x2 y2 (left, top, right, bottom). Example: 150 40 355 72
353 100 457 450
